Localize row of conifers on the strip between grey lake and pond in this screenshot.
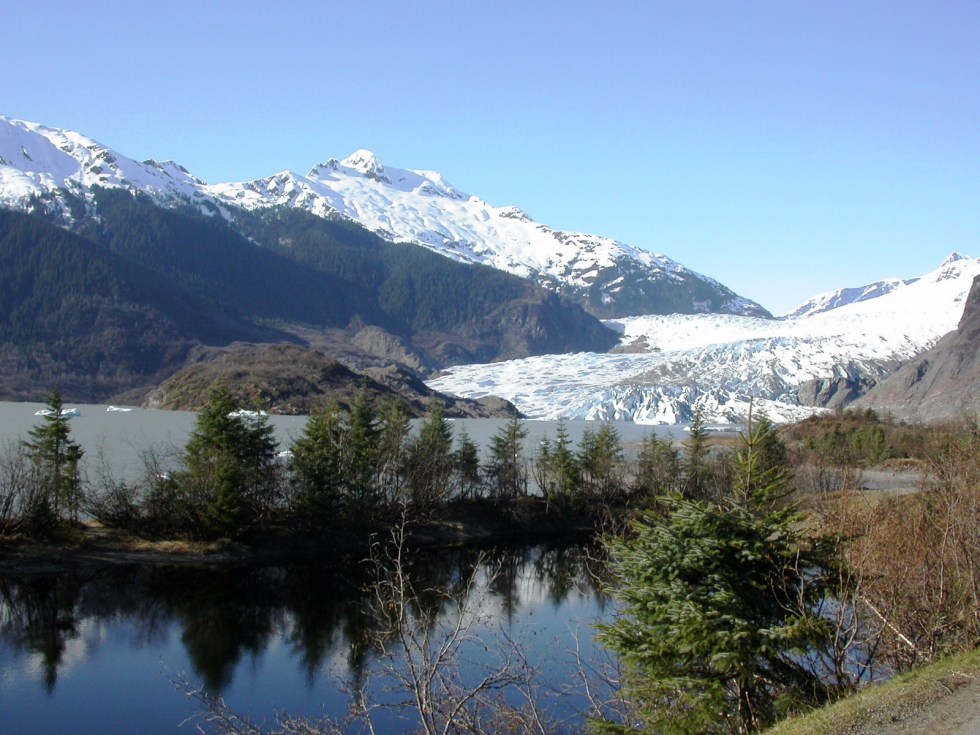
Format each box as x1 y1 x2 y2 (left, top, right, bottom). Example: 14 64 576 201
0 385 664 539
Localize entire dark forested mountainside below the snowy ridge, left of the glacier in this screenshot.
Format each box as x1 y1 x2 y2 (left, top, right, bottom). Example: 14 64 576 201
0 187 616 400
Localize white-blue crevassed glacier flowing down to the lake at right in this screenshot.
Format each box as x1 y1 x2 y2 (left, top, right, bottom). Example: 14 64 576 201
429 253 980 424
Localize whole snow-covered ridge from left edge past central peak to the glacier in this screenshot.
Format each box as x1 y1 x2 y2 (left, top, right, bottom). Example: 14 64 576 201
0 117 769 317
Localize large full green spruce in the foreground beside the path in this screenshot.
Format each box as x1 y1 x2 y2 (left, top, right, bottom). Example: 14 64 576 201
598 412 834 735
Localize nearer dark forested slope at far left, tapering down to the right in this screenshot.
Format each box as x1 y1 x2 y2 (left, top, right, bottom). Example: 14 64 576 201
0 209 288 400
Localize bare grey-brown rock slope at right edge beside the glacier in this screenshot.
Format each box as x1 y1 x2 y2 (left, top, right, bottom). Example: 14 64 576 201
854 276 980 421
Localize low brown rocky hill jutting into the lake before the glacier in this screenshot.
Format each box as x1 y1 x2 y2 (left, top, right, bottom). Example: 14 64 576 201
144 343 517 418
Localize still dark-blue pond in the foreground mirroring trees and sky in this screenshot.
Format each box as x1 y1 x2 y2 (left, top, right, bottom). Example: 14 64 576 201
0 545 608 735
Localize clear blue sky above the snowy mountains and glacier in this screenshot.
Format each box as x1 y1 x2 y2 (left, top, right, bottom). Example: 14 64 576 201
0 0 980 313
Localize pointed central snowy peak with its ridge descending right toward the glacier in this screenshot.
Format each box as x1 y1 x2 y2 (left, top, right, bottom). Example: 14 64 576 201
209 150 767 316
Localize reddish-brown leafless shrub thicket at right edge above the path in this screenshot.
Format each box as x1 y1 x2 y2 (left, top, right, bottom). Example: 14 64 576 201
847 422 980 669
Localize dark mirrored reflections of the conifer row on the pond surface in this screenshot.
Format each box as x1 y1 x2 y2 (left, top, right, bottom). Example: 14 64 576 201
0 545 604 731
